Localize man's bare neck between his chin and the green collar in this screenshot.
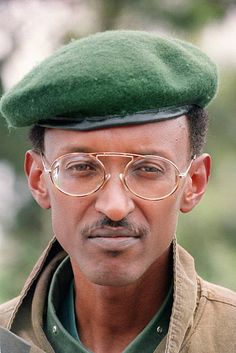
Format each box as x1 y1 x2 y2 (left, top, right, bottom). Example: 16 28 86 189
72 248 172 353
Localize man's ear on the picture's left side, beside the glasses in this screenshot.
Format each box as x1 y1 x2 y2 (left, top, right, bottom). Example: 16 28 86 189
25 150 51 209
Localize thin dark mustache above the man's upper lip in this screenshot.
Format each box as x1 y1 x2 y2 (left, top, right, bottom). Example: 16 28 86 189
81 216 149 237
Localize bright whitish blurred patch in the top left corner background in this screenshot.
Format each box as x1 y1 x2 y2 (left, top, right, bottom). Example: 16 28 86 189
0 0 97 90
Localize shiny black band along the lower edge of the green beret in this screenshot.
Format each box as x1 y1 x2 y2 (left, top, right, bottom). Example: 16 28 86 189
37 105 193 131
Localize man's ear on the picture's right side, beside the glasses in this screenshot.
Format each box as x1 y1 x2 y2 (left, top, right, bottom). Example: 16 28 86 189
180 153 211 213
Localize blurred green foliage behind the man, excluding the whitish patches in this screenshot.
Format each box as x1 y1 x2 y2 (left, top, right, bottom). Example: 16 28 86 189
0 0 236 301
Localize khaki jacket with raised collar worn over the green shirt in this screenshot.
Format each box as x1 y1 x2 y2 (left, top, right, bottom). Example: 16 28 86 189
0 236 236 353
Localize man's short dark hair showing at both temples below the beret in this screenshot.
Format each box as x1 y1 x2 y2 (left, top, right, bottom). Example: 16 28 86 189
29 106 209 156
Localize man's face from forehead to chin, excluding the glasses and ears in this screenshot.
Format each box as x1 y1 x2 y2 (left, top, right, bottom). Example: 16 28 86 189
29 117 195 286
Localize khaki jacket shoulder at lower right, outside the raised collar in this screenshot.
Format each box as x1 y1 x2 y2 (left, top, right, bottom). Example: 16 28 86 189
183 278 236 353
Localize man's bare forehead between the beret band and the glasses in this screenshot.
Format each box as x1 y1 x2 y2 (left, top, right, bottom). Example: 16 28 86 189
45 116 189 162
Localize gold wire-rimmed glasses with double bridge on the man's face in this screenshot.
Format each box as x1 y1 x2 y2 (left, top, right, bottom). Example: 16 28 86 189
41 152 195 201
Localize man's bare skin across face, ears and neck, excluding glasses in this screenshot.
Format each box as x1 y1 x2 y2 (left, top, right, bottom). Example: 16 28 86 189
25 116 210 353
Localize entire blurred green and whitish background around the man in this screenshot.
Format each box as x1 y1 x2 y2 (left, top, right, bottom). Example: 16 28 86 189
0 0 236 302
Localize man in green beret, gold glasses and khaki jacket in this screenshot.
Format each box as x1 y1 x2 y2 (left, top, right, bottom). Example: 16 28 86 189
0 31 236 353
